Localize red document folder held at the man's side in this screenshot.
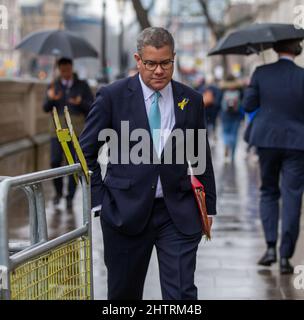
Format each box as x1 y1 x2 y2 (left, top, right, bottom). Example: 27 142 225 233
191 175 211 240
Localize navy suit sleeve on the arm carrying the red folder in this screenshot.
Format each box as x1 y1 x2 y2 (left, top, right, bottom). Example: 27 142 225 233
196 94 216 215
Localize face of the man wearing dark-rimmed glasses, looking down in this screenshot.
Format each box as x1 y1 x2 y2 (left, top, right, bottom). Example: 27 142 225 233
134 46 175 91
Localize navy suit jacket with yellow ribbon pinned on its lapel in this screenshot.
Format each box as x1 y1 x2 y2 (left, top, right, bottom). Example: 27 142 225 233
80 74 216 235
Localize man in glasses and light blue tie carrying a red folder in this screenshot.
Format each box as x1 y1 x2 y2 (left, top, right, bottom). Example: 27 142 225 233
80 28 216 300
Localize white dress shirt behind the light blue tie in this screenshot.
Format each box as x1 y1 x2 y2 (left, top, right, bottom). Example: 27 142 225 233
139 75 175 198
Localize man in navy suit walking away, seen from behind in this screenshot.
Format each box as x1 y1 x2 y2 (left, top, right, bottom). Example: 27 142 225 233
243 40 304 274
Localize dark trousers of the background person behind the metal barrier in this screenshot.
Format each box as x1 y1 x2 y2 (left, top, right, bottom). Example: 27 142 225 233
51 138 77 200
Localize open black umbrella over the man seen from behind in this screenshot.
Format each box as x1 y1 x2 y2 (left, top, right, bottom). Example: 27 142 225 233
208 23 304 56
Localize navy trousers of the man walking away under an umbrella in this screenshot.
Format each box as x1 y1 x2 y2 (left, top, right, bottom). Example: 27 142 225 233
258 148 304 258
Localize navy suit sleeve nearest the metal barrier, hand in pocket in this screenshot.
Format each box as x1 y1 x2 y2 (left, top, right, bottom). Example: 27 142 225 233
80 88 111 208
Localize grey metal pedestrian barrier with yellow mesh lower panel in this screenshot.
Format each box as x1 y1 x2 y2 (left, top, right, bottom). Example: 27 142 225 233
0 107 93 300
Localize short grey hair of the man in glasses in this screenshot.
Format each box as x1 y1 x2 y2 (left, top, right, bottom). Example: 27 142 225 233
137 27 174 54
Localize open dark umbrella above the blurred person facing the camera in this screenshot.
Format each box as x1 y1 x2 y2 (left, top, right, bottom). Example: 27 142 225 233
16 29 98 59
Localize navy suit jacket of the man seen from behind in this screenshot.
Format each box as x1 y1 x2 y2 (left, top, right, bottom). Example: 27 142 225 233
243 59 304 150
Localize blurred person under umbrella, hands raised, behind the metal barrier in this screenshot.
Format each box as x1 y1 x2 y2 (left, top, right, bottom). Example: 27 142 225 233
43 58 93 209
